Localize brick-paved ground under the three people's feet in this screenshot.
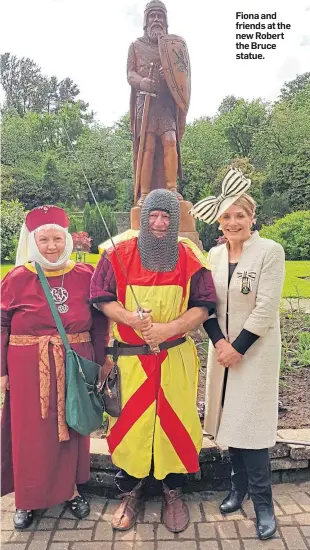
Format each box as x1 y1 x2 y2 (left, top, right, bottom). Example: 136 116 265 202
1 482 310 550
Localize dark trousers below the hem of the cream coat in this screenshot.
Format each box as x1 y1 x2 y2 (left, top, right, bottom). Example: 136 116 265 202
228 447 272 509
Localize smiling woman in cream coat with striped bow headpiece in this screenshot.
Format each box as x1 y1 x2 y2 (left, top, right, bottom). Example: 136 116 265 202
191 169 285 539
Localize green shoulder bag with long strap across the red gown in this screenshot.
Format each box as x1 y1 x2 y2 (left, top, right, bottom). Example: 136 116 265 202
35 263 104 435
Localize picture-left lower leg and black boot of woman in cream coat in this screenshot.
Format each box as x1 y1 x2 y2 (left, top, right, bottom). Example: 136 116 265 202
220 447 248 514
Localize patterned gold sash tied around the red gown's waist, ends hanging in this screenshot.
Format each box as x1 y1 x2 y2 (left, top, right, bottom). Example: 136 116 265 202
10 332 91 441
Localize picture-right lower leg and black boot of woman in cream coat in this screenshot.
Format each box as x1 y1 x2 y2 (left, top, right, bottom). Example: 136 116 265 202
243 449 277 540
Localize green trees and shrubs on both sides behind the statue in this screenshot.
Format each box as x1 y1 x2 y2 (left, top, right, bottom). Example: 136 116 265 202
0 53 310 260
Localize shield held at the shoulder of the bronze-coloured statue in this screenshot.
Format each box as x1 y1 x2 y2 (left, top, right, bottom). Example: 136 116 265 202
158 34 191 113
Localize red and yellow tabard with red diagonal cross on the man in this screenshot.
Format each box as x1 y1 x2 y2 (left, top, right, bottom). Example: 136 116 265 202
103 233 208 479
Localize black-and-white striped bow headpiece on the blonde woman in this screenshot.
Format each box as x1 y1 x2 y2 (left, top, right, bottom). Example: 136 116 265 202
189 168 251 224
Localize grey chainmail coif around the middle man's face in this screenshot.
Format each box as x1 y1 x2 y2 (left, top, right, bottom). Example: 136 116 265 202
138 189 180 272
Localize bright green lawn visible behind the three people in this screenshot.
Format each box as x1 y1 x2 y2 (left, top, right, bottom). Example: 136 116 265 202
1 254 310 298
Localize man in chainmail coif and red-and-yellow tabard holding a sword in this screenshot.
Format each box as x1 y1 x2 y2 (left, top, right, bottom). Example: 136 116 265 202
91 189 215 532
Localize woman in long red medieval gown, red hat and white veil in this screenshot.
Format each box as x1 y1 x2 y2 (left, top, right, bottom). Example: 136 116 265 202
1 206 107 529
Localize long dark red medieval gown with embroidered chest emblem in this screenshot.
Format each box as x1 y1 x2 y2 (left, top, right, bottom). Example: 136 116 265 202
1 262 108 510
